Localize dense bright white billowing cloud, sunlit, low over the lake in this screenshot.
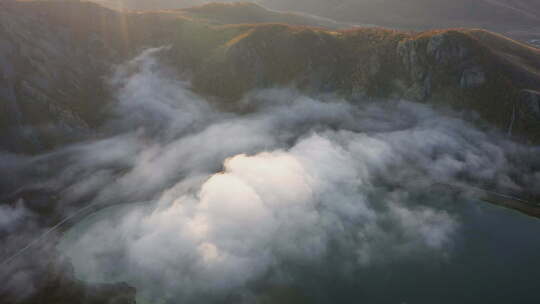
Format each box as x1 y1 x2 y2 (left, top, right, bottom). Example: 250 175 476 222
61 133 458 301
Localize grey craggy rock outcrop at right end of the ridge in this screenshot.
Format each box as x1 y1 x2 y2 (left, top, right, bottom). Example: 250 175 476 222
390 30 540 143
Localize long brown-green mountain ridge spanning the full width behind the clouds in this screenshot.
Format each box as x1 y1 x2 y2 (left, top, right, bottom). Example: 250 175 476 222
0 0 540 151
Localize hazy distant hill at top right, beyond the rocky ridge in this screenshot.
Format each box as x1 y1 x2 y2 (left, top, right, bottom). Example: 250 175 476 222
264 0 540 29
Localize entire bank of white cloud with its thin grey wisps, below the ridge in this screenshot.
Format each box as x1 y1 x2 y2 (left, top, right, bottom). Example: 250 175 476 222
0 49 540 303
